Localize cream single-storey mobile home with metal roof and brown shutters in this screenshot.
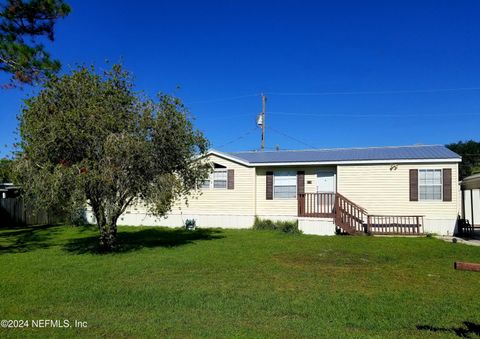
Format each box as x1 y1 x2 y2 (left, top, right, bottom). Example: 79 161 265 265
89 145 461 235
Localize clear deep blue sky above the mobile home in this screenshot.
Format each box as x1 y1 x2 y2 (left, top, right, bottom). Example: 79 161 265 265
0 0 480 156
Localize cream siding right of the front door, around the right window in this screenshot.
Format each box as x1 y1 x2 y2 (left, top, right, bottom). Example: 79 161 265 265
337 164 458 219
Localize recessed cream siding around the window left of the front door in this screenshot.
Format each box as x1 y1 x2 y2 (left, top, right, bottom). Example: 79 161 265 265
256 166 335 216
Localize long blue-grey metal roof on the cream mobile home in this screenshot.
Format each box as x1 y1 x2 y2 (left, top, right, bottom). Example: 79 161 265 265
225 145 461 164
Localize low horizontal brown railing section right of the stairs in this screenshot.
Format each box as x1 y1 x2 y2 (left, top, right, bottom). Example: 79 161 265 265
367 215 423 235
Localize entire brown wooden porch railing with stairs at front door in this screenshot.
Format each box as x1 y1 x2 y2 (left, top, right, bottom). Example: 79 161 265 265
298 193 423 235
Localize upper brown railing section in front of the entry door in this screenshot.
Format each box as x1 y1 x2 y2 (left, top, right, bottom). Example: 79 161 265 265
298 193 335 218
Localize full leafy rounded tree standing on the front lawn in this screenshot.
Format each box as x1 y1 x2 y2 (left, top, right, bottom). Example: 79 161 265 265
15 65 211 250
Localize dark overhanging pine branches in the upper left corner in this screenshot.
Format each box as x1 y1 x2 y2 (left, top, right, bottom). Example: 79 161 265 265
0 0 70 85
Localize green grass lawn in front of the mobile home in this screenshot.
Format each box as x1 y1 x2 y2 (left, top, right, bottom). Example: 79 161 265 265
0 226 480 338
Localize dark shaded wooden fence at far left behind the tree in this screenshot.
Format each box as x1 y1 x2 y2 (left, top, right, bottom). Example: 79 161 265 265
0 198 63 227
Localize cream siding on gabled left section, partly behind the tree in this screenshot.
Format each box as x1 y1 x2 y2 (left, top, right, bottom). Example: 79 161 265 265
126 155 255 216
